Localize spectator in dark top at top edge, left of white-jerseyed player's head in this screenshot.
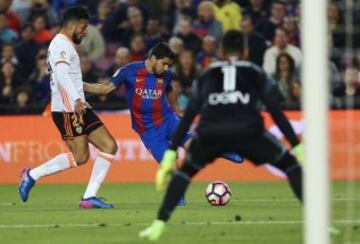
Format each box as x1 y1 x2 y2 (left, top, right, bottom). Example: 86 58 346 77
18 0 59 28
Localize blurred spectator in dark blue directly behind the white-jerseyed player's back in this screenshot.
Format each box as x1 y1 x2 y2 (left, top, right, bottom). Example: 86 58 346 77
29 55 50 105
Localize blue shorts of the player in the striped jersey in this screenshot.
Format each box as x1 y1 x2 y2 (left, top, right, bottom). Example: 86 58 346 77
139 115 193 163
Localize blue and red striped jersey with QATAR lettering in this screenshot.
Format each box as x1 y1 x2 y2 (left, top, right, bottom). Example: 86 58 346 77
111 61 174 134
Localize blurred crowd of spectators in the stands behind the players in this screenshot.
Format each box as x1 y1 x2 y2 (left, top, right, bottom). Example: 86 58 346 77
0 0 360 114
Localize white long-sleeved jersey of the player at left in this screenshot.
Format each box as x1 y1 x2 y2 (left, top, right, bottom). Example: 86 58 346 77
47 34 85 112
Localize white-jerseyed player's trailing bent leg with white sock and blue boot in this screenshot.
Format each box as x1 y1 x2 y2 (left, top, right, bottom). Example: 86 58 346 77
19 136 89 202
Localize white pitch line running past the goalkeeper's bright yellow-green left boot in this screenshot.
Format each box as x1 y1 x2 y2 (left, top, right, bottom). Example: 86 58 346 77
0 219 360 229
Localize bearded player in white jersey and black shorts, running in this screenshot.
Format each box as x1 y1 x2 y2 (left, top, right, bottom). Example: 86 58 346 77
19 6 117 208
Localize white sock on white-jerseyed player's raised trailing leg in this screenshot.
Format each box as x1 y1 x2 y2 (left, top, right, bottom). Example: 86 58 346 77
29 153 77 180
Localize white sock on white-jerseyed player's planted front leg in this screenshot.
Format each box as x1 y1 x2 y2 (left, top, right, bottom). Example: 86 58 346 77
83 152 115 199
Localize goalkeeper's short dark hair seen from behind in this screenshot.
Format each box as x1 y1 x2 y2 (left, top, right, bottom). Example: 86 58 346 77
222 30 245 54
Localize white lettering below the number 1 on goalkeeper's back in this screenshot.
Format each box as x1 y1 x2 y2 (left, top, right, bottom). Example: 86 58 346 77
209 91 250 106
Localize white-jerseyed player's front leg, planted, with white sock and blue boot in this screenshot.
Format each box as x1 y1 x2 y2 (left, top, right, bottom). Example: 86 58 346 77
79 126 117 208
